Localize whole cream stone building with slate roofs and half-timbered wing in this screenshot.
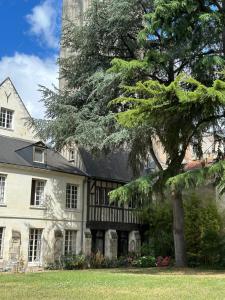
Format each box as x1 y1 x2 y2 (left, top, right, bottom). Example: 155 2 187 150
0 78 141 269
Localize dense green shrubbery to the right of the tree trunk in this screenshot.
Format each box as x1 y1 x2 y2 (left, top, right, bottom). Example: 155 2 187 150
185 193 225 267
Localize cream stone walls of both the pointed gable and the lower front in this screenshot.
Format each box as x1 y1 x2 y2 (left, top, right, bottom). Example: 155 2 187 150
0 79 87 269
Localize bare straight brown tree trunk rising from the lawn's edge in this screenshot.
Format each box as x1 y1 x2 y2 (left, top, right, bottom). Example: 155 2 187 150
172 191 186 268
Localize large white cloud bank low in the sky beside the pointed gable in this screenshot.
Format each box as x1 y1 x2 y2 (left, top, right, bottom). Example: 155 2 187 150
0 53 58 118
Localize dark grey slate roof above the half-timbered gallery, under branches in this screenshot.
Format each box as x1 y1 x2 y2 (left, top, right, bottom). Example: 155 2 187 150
80 149 133 182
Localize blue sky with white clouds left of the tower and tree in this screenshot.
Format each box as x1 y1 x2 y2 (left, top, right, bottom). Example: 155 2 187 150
0 0 62 118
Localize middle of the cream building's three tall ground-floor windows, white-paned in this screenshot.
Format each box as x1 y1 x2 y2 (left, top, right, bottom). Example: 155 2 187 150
28 228 42 262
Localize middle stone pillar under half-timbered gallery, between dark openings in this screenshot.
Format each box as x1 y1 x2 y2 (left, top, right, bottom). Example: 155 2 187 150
105 229 118 259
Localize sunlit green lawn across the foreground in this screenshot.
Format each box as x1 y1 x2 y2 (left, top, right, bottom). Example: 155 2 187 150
0 268 225 300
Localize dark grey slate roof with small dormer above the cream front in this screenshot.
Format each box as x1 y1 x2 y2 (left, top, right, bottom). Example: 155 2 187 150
0 135 87 176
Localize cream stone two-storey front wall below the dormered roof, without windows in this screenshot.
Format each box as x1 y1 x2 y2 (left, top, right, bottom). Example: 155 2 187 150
0 165 85 267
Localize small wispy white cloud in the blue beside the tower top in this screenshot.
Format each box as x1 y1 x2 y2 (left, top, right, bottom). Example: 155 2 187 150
26 0 60 49
